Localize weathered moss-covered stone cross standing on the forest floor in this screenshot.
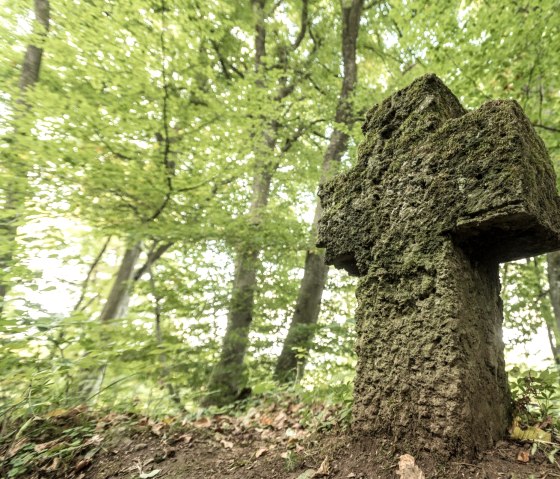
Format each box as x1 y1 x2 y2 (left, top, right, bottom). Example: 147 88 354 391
318 75 560 457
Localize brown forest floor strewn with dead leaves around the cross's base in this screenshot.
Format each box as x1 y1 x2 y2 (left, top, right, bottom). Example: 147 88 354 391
0 402 560 479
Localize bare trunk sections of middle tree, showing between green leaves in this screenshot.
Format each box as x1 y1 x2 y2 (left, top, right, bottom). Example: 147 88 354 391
202 0 281 406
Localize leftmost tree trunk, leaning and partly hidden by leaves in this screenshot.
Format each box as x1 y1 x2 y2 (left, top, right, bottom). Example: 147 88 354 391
0 0 50 317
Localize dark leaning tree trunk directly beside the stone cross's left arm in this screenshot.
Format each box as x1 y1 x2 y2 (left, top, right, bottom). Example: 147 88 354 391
275 0 363 382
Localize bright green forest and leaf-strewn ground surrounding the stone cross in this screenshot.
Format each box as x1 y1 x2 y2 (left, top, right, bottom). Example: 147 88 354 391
0 0 560 479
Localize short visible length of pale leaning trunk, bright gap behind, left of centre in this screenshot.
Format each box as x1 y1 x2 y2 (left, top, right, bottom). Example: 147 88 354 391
99 242 142 322
